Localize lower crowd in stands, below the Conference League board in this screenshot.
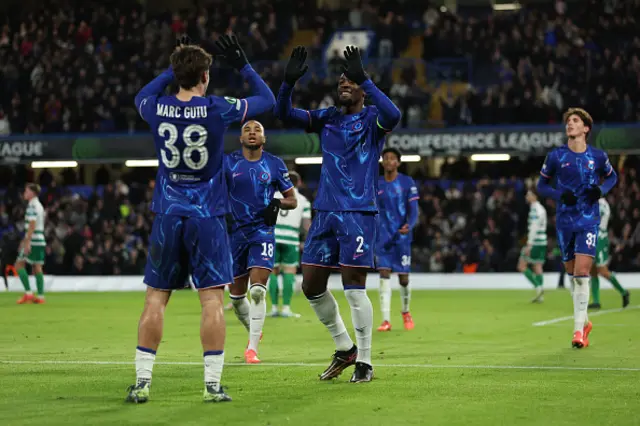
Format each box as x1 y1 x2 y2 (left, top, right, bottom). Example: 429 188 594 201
0 157 640 275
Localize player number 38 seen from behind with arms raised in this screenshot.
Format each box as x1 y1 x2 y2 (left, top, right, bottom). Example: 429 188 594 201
127 36 275 403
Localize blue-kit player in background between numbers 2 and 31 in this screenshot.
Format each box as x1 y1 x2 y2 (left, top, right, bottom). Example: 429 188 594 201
376 148 419 331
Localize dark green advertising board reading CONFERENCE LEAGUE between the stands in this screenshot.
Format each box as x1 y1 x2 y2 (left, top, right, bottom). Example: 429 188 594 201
0 125 640 164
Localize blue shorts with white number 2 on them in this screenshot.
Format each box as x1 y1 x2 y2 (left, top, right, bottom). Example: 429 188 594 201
302 211 377 269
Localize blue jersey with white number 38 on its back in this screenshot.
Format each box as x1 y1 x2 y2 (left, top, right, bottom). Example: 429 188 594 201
138 95 248 218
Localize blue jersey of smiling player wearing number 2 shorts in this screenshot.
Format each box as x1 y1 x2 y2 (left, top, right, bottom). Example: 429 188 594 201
307 106 386 212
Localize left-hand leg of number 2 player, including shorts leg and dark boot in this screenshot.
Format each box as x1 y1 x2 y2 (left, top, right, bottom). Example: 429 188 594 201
302 211 358 380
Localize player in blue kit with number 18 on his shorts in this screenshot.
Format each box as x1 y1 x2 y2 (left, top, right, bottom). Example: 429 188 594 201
225 120 298 364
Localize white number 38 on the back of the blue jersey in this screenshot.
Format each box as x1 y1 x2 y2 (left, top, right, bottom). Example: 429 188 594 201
158 123 209 170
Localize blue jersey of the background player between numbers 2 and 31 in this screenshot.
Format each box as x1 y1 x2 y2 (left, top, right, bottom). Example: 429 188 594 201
378 173 419 244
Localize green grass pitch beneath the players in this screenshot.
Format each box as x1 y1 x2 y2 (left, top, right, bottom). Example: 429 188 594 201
0 291 640 426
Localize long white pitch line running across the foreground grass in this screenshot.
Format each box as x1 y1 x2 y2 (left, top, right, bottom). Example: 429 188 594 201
0 360 640 372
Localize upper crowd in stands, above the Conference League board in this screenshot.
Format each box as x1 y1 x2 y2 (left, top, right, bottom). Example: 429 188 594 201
0 0 640 134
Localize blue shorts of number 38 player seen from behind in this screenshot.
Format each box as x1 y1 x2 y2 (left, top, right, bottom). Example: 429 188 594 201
144 214 233 290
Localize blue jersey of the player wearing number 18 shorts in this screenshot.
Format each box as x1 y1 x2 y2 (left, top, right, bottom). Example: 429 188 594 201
224 151 293 233
